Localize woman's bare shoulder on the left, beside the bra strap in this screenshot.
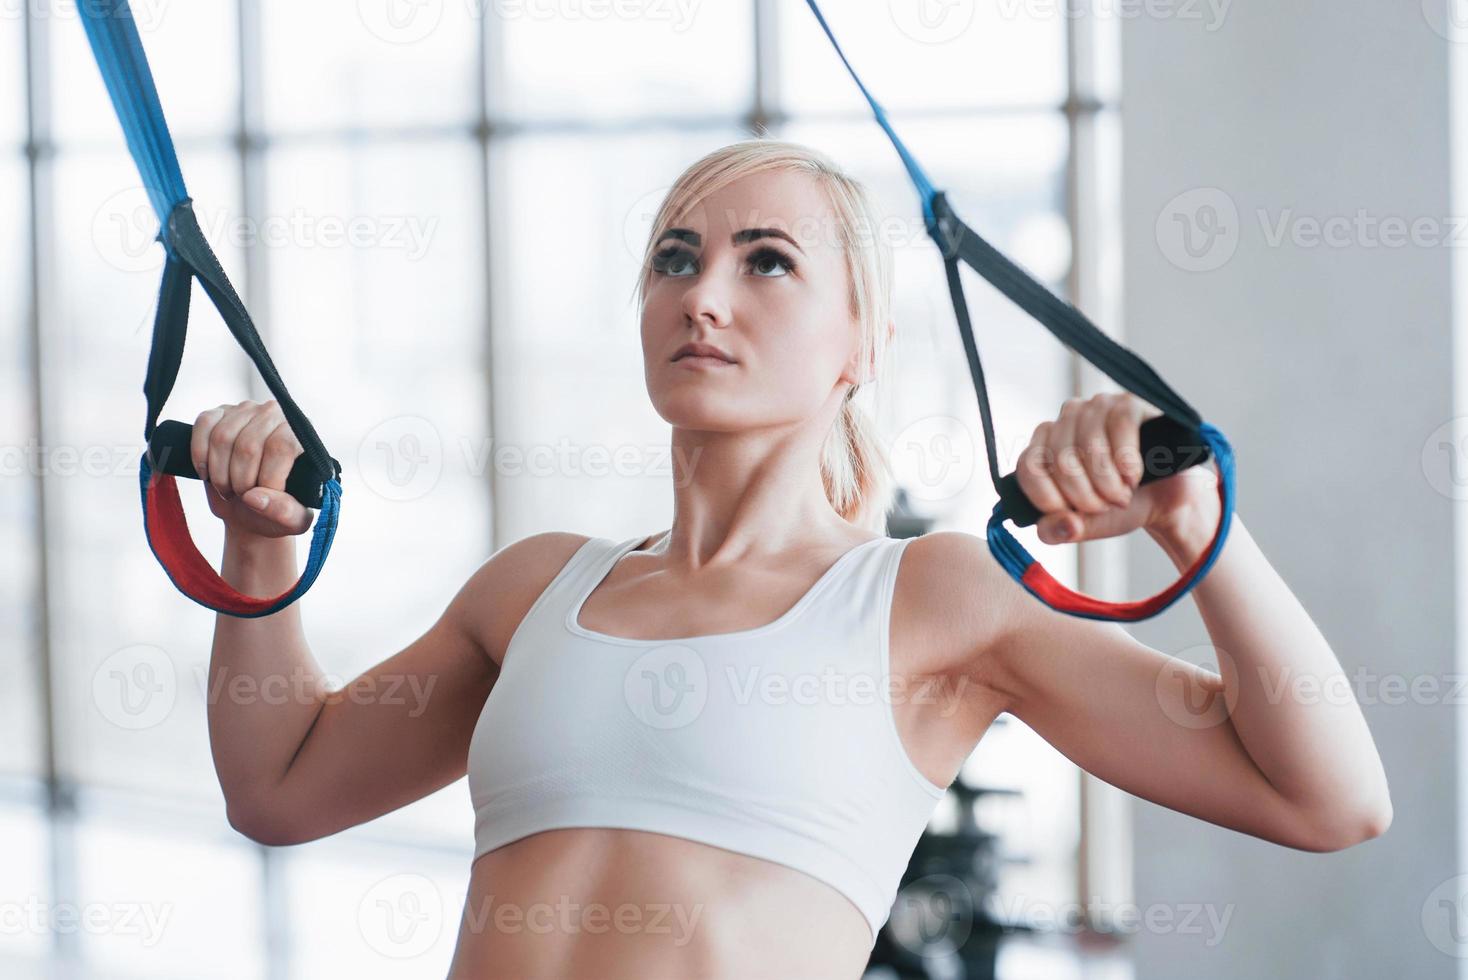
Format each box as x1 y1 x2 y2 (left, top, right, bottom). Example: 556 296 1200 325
459 531 592 665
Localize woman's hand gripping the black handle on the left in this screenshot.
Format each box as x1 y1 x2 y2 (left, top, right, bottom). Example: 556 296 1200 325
189 401 311 537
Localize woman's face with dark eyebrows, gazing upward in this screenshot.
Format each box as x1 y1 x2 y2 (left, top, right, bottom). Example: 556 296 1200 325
642 173 860 431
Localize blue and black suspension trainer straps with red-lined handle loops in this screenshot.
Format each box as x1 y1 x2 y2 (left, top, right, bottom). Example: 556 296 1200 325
78 0 1235 622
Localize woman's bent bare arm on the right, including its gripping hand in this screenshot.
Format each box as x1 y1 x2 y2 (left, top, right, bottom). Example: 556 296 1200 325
951 399 1392 851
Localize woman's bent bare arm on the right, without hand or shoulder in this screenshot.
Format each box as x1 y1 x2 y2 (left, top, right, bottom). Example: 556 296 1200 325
989 516 1392 851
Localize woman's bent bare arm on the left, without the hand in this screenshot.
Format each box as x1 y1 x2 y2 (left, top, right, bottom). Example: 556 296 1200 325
208 528 499 844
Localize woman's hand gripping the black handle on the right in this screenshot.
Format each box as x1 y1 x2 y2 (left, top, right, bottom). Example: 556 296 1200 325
1016 392 1217 544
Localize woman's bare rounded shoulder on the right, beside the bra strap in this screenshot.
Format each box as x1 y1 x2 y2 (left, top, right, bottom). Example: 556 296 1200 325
893 531 1028 701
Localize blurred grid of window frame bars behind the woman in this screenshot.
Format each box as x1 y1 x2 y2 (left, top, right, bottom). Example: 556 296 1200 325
14 0 1132 962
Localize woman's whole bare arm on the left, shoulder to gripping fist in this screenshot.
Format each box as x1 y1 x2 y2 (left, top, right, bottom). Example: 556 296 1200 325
191 402 586 845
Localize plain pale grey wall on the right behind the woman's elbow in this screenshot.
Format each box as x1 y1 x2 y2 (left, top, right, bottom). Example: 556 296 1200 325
1105 0 1468 980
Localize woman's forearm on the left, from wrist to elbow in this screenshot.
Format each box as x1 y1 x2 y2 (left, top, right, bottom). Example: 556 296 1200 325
207 533 324 811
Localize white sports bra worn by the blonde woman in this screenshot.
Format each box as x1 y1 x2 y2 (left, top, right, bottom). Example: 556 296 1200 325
468 537 944 943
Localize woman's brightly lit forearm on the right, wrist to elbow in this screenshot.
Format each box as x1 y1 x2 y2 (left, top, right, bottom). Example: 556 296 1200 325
1149 493 1390 835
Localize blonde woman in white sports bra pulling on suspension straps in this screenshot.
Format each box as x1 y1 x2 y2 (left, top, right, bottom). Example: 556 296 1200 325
192 139 1392 979
